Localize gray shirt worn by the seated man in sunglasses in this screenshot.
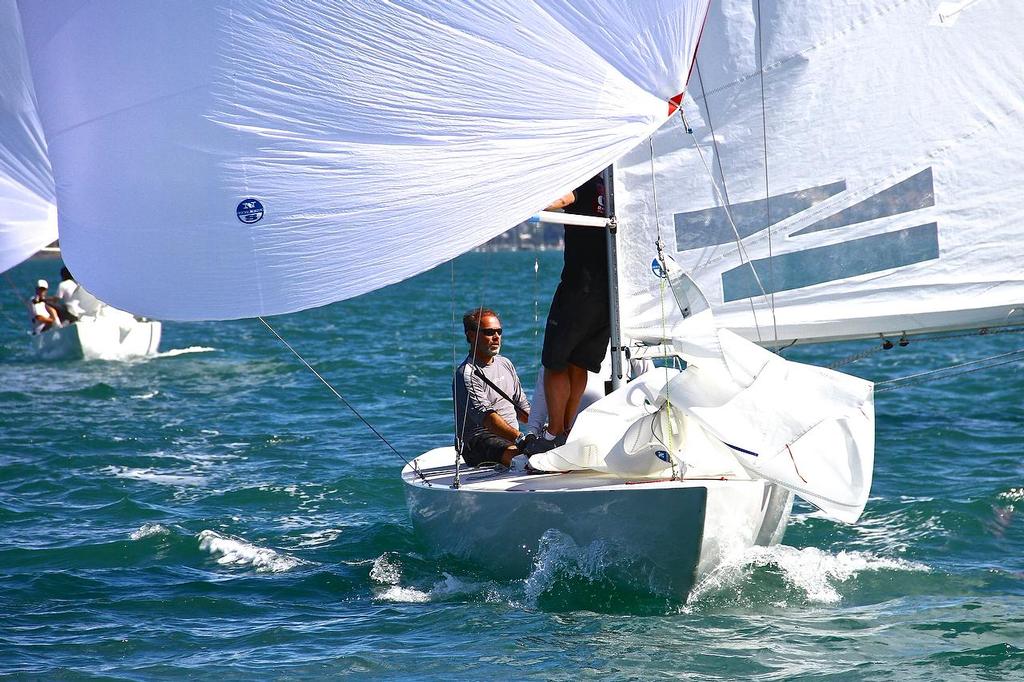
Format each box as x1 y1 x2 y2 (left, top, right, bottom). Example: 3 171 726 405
452 355 529 441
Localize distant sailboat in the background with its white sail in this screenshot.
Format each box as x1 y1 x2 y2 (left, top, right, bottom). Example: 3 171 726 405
0 0 161 359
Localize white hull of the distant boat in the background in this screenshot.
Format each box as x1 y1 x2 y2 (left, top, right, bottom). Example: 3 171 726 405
32 314 162 360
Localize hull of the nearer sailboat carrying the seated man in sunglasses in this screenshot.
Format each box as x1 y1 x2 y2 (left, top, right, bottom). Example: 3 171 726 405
402 447 793 600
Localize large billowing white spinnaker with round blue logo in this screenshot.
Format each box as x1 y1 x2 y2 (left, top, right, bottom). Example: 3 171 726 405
20 0 709 319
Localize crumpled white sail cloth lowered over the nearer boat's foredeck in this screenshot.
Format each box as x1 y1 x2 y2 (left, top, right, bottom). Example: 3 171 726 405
530 276 874 523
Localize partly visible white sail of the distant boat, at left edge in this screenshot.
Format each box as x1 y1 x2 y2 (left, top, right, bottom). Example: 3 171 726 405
0 0 57 272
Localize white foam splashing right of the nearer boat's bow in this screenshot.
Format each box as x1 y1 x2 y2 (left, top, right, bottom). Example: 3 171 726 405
689 545 931 604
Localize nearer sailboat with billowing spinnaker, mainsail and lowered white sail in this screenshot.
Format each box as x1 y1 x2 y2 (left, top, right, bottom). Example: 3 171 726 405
19 0 1024 599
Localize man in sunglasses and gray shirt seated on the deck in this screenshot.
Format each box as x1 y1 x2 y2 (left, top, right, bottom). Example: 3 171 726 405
452 307 529 467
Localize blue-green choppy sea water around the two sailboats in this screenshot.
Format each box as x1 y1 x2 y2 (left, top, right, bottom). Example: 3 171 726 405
0 253 1024 681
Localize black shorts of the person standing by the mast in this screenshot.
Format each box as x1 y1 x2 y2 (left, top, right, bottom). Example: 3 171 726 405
541 281 611 372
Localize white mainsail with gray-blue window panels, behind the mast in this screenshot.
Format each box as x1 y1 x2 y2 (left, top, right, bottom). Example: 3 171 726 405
615 0 1024 343
